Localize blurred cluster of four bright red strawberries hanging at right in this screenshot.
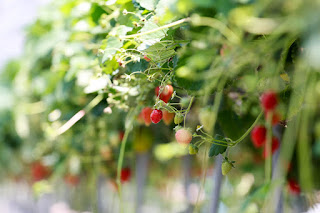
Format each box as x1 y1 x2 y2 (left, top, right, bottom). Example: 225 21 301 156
251 91 280 158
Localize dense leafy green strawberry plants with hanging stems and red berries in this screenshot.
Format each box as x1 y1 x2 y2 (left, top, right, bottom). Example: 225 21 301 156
0 0 320 212
